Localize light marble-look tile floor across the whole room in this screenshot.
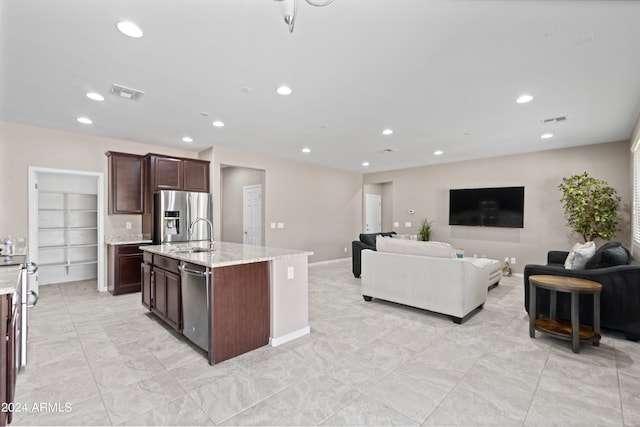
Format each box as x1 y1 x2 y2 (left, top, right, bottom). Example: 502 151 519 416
14 260 640 426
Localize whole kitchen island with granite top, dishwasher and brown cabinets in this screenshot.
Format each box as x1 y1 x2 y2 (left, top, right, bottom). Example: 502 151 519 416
140 241 312 365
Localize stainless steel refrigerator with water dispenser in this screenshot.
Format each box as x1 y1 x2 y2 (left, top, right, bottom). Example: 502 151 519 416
152 190 213 245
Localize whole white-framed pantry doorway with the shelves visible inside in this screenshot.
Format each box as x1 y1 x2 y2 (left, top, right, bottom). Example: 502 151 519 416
28 167 107 292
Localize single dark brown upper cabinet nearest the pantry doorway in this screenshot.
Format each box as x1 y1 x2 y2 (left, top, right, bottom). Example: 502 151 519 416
106 151 144 215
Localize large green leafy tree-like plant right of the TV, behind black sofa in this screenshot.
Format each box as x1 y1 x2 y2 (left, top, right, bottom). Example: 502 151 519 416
558 172 621 242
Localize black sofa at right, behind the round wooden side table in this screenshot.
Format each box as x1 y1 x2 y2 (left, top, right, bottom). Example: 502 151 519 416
524 242 640 341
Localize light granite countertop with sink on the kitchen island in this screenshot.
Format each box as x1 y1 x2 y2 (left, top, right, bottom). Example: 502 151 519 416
140 241 313 268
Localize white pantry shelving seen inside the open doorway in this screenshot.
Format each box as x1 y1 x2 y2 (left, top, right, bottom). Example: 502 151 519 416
38 191 98 285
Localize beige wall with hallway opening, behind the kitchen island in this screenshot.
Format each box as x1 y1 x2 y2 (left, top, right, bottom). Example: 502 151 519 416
209 147 363 262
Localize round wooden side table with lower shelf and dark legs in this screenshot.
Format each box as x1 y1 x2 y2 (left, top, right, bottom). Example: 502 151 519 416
529 275 602 353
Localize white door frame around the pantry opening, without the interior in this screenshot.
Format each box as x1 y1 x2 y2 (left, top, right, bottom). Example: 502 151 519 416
27 166 107 292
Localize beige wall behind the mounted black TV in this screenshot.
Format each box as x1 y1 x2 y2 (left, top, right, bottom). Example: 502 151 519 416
363 141 632 272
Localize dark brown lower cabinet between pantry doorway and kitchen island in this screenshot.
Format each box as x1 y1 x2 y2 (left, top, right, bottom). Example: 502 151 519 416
107 243 147 295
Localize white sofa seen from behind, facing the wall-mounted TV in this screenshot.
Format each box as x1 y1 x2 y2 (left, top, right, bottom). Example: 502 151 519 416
361 236 492 323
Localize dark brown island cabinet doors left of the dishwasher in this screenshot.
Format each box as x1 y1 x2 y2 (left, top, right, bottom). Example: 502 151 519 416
138 253 182 331
